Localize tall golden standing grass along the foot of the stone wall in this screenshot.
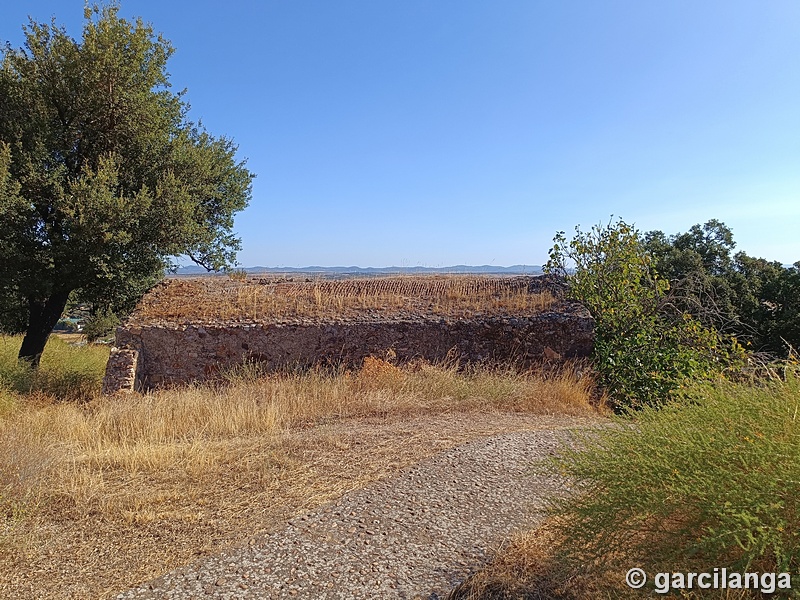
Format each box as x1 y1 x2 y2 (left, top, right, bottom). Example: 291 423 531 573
0 358 590 480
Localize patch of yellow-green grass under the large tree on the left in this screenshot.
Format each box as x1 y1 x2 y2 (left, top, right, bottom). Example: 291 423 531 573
0 336 109 404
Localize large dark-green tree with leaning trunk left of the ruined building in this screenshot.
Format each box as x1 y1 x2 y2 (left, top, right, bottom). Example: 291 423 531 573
0 3 254 365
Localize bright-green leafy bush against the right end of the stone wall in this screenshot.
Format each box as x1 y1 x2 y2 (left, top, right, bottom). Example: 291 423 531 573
546 219 738 408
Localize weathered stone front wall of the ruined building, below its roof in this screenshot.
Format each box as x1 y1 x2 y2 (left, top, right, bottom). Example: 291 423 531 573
108 305 594 389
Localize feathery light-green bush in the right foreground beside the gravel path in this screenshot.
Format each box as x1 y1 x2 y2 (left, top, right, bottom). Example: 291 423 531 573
553 376 800 596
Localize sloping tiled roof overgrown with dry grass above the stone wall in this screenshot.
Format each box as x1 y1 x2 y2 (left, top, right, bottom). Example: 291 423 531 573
133 275 555 324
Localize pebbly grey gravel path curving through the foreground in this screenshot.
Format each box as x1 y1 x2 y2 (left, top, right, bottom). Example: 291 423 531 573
117 430 580 600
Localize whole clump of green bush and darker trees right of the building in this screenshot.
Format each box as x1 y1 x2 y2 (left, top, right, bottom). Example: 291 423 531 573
545 219 800 408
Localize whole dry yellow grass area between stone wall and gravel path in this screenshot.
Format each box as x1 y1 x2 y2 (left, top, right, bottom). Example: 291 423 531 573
0 359 597 598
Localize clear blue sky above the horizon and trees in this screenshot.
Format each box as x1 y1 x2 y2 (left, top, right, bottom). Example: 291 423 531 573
0 0 800 266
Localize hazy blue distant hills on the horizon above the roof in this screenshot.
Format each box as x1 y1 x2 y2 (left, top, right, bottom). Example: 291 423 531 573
173 265 542 275
